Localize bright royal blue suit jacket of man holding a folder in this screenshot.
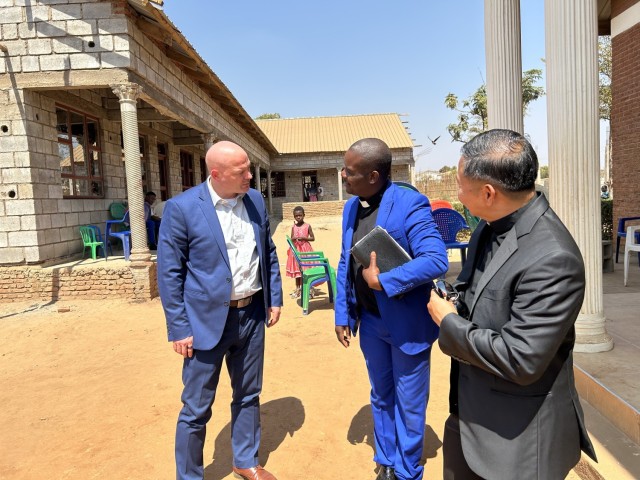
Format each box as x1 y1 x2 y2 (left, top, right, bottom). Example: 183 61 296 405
336 184 449 355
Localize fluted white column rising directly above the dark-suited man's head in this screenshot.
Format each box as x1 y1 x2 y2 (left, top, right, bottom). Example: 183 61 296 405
484 0 524 134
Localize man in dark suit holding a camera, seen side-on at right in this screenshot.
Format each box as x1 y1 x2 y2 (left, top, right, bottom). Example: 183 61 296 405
428 130 595 480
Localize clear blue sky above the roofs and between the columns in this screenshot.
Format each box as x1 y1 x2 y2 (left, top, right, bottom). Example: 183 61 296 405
164 0 547 170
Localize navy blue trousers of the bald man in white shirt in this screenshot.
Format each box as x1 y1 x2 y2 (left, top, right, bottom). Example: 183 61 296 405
175 299 265 480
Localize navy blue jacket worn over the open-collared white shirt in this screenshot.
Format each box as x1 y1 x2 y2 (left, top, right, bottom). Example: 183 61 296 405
158 182 282 350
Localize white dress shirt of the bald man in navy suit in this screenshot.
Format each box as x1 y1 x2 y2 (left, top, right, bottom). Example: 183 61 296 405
207 177 262 300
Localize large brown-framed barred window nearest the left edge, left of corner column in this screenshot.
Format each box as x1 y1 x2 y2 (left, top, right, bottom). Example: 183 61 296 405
56 105 104 198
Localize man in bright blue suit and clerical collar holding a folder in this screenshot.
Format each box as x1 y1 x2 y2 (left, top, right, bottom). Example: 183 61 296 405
335 138 448 480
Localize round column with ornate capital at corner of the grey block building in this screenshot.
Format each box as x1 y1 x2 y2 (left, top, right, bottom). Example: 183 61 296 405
111 83 151 262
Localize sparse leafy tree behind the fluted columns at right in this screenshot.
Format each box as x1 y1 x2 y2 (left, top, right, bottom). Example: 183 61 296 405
444 68 544 142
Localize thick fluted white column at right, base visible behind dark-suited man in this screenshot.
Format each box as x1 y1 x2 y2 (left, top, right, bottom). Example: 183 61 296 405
545 0 613 352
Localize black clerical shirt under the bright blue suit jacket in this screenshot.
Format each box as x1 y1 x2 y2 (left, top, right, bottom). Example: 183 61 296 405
351 182 391 316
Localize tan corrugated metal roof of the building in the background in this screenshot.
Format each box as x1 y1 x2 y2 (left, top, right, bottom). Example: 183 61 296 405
256 113 413 153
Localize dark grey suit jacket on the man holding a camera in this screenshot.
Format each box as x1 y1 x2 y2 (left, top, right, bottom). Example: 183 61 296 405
439 193 595 480
